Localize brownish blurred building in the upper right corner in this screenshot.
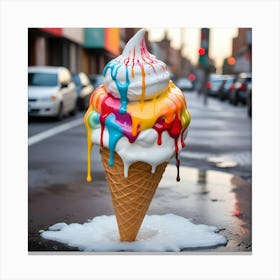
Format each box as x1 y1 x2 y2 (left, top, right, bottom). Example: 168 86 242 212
232 28 252 73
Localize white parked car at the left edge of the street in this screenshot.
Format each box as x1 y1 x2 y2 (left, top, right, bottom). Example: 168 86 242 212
28 66 78 120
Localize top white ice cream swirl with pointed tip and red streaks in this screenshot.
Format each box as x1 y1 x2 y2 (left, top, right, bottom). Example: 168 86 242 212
104 29 170 101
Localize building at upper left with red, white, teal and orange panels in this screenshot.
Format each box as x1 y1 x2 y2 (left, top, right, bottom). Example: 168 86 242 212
28 28 120 74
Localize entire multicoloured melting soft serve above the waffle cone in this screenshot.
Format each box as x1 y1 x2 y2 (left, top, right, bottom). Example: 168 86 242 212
84 29 190 181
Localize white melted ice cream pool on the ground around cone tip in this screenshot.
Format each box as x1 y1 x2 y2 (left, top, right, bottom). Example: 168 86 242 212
40 214 227 252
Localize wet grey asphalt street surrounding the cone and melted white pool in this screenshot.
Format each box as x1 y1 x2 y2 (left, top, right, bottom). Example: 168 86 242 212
28 92 252 252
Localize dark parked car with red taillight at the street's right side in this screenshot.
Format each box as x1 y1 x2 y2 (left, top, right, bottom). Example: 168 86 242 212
229 73 252 105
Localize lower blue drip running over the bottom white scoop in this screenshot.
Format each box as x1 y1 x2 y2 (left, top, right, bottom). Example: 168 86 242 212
105 113 123 166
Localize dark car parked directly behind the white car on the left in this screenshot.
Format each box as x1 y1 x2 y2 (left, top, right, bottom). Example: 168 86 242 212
72 72 93 110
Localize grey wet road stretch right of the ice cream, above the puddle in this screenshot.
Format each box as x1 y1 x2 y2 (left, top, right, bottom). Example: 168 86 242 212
181 93 252 182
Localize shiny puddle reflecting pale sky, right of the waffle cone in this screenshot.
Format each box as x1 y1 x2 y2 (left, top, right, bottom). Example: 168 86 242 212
155 165 251 246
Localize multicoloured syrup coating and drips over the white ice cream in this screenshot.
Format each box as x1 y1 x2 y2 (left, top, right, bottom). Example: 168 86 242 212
84 29 190 181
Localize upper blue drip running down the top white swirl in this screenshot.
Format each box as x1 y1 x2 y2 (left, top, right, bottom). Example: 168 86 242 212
103 60 130 114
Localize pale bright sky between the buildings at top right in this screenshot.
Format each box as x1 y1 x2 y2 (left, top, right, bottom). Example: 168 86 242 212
147 28 238 69
